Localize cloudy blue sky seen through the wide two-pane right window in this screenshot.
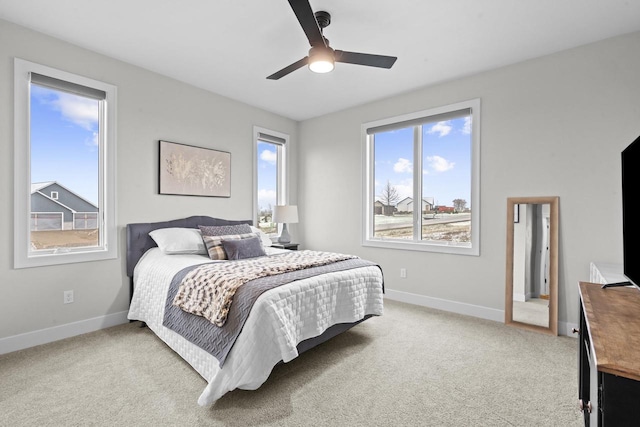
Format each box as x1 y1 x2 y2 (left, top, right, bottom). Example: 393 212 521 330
374 117 471 208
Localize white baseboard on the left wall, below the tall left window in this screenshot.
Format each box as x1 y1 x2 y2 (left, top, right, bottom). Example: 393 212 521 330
0 311 129 354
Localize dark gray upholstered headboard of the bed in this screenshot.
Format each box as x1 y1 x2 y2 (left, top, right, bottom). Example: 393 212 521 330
127 216 253 277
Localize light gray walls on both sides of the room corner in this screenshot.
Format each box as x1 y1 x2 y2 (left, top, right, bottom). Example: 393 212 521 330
0 15 640 339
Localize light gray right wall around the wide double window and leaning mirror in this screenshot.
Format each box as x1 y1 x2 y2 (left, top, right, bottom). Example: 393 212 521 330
298 33 640 332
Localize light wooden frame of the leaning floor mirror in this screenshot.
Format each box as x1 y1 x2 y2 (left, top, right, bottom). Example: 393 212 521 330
504 196 559 335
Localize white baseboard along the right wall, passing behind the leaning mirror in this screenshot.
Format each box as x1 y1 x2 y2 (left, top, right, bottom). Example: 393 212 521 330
384 288 577 337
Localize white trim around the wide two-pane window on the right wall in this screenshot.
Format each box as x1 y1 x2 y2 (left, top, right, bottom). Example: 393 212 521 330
361 98 480 256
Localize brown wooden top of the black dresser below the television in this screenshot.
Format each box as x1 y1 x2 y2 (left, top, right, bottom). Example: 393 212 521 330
580 282 640 381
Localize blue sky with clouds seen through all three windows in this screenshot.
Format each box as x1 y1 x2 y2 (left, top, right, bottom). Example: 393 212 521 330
31 85 471 209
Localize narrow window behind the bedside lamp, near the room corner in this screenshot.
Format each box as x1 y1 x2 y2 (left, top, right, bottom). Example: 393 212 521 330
253 127 289 236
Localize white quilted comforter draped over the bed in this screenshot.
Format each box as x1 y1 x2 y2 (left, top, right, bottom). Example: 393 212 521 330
128 248 383 406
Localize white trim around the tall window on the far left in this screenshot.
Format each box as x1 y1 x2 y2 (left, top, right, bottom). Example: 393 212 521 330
13 58 118 268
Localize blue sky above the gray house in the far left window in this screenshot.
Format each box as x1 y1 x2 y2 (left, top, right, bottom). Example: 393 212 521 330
30 84 99 205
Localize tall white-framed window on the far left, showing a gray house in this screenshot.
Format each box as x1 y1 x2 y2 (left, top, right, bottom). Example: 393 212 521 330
14 58 117 268
